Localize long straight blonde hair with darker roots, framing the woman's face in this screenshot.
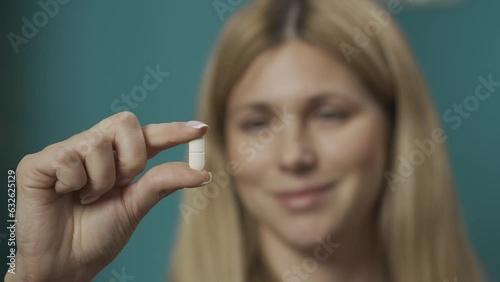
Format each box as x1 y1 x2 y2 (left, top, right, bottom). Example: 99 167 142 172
171 0 484 282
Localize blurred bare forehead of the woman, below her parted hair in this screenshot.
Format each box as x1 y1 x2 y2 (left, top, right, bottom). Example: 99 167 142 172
228 41 367 107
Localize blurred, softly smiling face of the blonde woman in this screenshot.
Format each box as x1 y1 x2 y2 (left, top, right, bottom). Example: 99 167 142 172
226 41 389 247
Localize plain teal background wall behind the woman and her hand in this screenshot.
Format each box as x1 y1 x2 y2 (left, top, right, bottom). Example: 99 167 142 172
0 0 500 282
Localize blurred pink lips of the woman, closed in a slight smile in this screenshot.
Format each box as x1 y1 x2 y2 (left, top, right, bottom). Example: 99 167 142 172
275 183 334 211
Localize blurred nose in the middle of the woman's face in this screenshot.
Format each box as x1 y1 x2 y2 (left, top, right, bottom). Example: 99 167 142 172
276 124 317 174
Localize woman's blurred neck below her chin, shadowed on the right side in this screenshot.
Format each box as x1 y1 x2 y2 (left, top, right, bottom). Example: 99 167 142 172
259 218 388 282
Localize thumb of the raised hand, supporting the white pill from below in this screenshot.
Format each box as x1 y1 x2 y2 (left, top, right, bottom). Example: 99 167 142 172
122 162 212 223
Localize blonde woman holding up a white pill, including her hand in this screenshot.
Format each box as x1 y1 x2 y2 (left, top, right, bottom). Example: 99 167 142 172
6 0 484 282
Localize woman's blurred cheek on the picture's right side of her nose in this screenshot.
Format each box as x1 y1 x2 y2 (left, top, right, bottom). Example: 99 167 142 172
316 113 387 224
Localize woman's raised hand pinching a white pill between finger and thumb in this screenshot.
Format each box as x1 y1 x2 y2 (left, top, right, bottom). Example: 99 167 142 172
2 112 211 282
